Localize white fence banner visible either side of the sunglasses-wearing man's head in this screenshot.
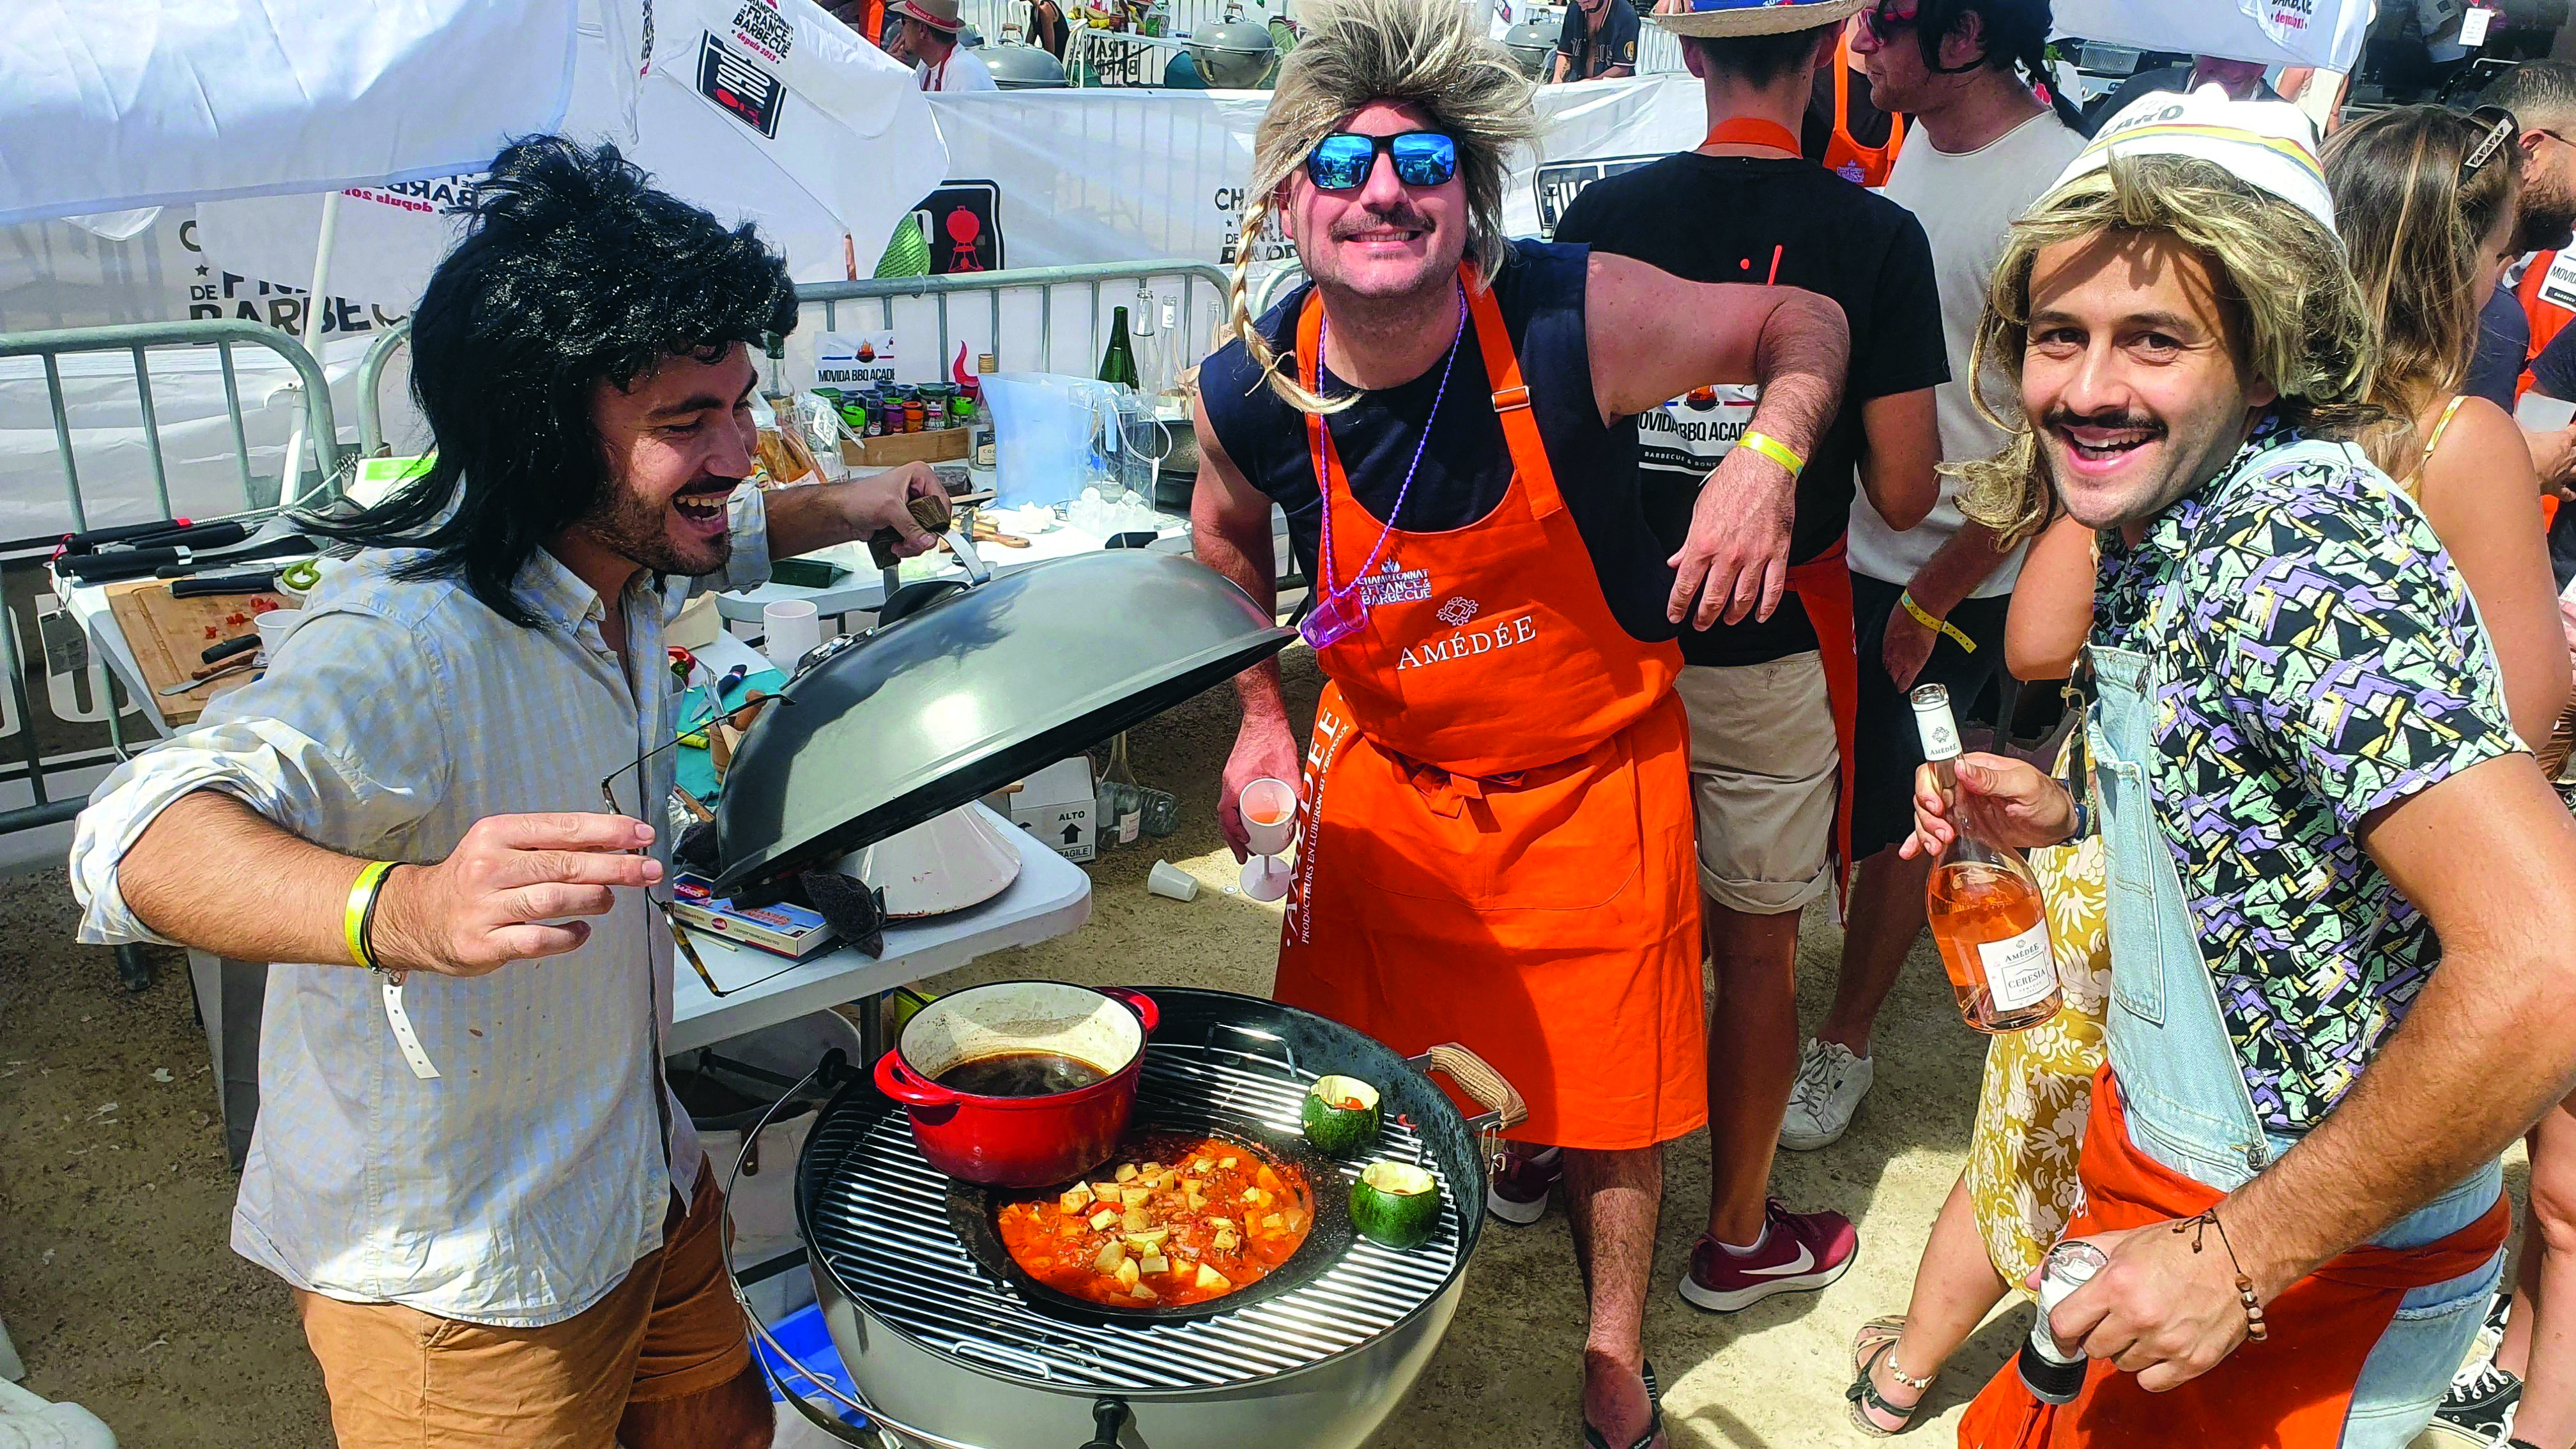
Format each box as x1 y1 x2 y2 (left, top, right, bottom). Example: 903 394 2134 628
924 75 1708 273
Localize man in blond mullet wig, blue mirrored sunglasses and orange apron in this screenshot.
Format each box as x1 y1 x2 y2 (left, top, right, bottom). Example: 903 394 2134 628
1193 0 1847 1449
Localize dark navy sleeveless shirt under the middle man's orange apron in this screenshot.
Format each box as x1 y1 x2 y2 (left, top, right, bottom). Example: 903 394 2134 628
1198 242 1680 640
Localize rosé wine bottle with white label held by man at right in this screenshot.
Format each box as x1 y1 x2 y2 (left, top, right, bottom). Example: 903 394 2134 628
1914 683 2064 1031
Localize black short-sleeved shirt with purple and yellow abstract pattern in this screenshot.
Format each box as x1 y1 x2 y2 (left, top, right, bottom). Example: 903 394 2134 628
2094 431 2522 1132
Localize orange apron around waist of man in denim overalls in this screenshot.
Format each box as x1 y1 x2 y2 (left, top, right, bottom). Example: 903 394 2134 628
1958 1065 2511 1449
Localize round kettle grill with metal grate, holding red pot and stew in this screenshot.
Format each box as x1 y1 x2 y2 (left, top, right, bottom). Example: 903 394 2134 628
755 988 1525 1449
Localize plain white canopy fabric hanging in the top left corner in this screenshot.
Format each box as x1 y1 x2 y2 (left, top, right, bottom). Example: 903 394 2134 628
0 0 574 224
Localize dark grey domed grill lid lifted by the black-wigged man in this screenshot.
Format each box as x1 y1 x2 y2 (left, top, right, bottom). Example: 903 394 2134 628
714 549 1296 900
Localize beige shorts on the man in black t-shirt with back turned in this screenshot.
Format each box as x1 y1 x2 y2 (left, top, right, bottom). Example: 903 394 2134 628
1680 650 1842 916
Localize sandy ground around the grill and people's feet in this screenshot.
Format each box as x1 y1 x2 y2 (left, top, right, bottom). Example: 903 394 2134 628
0 655 2519 1449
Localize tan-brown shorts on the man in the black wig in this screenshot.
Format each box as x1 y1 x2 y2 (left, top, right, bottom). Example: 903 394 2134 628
296 1168 752 1449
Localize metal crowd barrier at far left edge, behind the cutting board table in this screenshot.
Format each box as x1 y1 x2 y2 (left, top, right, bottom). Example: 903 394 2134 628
0 317 345 836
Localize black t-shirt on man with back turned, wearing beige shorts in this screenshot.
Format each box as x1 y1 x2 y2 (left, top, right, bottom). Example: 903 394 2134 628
1556 152 1950 665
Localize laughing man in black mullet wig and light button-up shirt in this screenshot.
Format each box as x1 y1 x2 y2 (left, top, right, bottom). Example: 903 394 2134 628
75 137 938 1449
